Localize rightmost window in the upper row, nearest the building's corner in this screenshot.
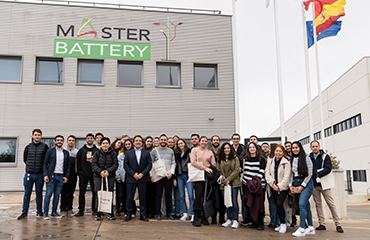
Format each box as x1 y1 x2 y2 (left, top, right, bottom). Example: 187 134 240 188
194 64 218 88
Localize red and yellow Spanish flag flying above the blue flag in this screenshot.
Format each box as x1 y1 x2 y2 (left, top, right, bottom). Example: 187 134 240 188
304 0 346 34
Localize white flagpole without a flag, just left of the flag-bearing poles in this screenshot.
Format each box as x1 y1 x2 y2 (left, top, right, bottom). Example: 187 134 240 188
274 0 285 144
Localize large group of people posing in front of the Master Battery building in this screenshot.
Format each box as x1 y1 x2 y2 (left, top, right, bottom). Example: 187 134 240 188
18 129 343 236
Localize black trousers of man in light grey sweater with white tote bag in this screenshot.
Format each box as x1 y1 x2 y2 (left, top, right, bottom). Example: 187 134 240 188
155 177 173 216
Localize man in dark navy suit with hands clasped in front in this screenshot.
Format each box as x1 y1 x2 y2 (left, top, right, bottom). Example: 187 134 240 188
124 135 152 221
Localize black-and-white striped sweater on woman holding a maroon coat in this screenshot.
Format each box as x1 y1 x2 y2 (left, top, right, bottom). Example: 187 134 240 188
243 157 266 188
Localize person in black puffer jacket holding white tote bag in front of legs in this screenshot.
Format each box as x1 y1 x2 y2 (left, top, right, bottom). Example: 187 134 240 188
91 137 118 220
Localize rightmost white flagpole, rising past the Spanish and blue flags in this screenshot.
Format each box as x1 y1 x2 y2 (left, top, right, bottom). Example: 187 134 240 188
311 1 326 151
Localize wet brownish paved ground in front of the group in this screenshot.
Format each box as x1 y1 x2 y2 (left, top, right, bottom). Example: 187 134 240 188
0 193 370 240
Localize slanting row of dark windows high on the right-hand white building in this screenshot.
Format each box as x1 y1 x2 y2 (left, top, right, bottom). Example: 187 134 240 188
299 113 362 145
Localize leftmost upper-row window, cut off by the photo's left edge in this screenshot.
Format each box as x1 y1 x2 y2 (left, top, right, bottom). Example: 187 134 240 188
0 56 22 82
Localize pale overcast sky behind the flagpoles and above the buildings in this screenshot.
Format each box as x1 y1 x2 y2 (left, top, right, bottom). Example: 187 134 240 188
75 0 370 138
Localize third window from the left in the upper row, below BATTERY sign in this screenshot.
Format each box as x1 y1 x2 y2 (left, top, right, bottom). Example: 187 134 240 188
78 60 104 84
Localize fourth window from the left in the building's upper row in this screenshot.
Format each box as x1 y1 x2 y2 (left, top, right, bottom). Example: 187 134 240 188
118 62 143 86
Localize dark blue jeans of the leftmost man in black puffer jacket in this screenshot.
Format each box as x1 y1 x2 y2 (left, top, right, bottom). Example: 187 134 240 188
22 173 44 213
